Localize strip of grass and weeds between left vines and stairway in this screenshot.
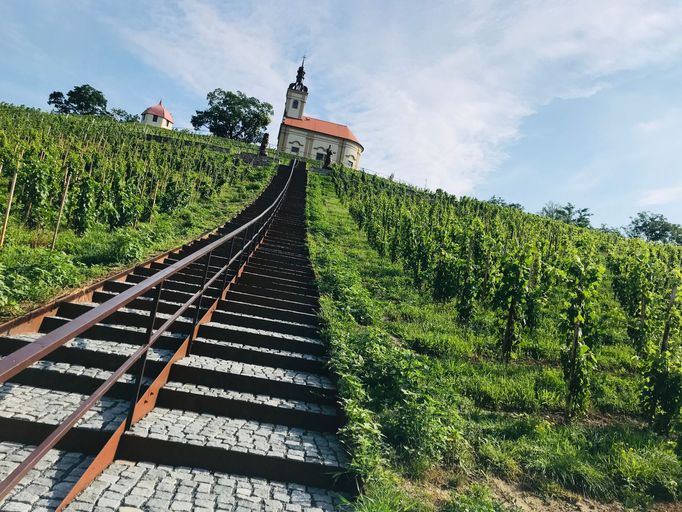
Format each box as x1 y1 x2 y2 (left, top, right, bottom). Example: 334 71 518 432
0 166 274 320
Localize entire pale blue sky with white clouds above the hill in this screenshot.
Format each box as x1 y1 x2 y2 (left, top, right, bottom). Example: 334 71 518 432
0 0 682 226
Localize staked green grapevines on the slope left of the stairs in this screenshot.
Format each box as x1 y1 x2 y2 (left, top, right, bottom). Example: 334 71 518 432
0 104 270 246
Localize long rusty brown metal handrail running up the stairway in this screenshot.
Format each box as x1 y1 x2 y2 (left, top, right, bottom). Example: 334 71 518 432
0 159 297 499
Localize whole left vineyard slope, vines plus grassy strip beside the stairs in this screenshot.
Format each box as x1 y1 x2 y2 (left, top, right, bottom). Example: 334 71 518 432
0 105 274 316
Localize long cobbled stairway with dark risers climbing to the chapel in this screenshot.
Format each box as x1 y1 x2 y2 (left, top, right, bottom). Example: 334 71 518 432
0 167 353 511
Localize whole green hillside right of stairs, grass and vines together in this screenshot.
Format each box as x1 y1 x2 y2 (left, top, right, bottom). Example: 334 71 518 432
308 171 682 511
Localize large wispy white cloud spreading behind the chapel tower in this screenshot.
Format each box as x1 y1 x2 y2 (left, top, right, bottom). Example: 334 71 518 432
109 0 682 193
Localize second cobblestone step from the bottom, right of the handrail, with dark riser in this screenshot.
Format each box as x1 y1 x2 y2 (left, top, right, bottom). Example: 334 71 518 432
113 407 351 490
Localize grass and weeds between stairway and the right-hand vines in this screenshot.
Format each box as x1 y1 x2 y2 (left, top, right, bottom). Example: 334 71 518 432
308 173 682 511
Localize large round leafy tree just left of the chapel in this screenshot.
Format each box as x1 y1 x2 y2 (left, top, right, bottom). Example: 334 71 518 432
191 89 275 143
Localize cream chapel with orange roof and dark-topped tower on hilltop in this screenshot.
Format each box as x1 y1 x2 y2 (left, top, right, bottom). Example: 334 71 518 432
277 59 364 169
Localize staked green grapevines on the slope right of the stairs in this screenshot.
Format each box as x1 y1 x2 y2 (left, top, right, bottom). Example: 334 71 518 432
332 168 682 422
